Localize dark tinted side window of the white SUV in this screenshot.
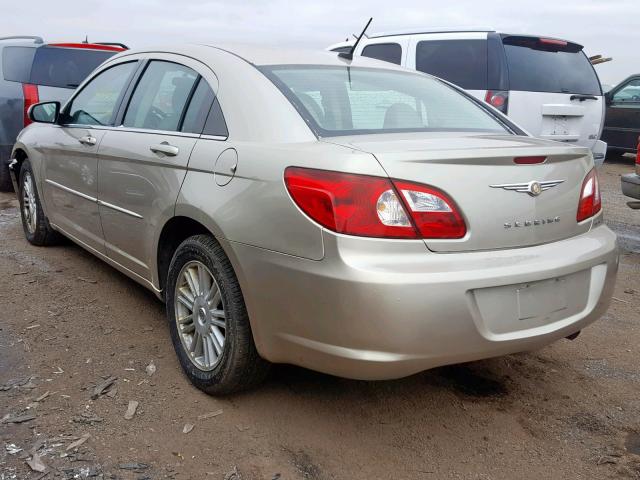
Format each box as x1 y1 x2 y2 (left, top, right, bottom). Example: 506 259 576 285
416 39 487 90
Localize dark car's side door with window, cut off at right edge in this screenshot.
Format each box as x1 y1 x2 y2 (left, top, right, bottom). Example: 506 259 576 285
602 77 640 150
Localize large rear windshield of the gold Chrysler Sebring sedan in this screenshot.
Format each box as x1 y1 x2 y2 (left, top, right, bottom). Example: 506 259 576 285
261 65 508 136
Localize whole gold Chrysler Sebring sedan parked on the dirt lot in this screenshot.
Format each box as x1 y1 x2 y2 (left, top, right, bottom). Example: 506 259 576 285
10 45 617 394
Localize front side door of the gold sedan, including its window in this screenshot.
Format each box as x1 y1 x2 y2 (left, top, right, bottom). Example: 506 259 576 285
39 62 137 253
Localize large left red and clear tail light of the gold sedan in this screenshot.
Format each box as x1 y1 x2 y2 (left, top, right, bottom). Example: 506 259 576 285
284 167 467 239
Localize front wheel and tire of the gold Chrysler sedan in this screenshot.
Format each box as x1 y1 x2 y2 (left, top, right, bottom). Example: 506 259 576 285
18 160 60 247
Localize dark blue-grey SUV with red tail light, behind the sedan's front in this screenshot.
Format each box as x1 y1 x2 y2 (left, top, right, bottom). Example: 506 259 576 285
0 36 126 191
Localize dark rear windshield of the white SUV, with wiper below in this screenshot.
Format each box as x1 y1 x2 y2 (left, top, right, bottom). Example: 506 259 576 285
503 36 602 95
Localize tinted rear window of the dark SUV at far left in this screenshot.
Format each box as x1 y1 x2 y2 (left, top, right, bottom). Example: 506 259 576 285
29 47 116 88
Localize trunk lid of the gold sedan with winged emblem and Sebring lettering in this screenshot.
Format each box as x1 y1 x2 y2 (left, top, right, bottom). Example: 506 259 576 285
324 132 593 252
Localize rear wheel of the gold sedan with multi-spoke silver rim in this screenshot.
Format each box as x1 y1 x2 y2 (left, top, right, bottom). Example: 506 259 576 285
166 235 270 395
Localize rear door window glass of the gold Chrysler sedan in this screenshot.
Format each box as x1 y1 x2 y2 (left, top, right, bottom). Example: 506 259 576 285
123 60 198 132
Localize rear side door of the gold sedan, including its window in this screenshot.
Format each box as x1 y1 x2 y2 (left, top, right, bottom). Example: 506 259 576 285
98 55 217 280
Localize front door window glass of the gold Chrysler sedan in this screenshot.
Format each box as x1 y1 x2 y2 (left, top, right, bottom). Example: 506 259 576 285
65 62 138 125
